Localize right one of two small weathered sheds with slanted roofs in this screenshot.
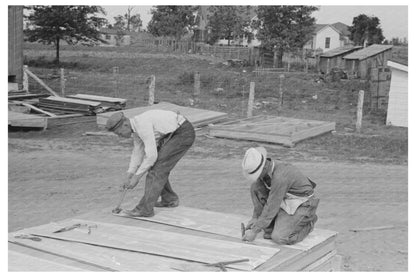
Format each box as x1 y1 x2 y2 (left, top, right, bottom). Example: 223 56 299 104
344 44 393 79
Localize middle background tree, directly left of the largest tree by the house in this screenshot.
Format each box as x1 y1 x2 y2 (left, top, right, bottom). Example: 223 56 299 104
207 6 252 45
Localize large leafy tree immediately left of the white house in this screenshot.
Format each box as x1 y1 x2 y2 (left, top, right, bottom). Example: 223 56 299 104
252 6 318 67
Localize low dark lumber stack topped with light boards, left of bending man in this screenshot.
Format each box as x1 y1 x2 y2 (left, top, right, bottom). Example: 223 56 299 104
38 96 102 115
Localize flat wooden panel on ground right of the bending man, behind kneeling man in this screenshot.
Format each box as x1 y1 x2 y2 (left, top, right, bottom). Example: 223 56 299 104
209 116 335 147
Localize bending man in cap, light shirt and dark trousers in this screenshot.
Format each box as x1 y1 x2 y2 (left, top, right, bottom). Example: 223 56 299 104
106 110 195 217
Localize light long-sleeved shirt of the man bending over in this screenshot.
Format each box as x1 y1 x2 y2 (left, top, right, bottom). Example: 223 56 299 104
127 110 186 175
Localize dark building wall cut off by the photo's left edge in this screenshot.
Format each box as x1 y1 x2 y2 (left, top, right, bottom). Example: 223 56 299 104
8 6 23 89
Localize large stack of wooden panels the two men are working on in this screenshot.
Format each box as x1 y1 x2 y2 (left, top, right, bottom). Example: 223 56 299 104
8 207 340 272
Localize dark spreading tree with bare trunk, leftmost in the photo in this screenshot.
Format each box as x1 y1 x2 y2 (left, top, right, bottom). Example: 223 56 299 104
25 6 107 64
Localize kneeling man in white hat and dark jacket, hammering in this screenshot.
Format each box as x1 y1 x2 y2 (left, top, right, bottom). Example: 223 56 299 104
242 147 319 244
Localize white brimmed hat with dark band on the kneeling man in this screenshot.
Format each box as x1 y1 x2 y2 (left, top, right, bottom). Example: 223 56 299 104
242 147 267 182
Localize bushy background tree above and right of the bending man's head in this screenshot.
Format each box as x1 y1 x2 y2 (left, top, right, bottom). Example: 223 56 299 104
147 6 198 40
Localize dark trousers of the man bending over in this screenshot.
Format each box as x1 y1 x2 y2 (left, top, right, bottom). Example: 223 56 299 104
136 120 195 216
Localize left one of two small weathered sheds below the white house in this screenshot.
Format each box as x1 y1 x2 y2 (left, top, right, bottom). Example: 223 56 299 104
318 46 362 73
